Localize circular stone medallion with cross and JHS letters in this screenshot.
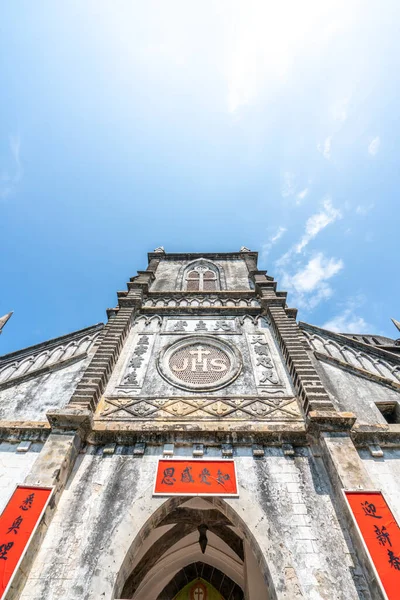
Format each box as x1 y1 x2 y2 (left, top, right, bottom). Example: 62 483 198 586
157 335 242 391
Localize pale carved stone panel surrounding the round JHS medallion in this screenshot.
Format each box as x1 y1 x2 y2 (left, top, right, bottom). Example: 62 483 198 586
105 316 293 398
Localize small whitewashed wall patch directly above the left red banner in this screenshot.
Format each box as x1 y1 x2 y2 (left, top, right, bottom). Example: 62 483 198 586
0 442 42 514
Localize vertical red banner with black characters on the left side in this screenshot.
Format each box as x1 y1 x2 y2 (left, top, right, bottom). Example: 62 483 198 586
0 486 52 598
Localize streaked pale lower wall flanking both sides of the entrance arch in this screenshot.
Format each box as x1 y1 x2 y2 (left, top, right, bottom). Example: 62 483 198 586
21 448 369 600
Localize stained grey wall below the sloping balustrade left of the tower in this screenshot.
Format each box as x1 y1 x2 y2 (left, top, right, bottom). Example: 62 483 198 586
0 358 90 421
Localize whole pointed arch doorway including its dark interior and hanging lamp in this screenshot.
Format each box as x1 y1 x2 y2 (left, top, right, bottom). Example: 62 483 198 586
114 497 275 600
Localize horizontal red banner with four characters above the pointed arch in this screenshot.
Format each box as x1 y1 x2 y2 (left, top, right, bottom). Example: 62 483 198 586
154 459 238 496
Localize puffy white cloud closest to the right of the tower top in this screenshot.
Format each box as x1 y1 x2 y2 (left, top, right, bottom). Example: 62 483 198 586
281 252 344 310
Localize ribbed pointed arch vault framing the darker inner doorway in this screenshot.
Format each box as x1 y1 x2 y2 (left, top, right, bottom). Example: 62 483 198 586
113 497 275 600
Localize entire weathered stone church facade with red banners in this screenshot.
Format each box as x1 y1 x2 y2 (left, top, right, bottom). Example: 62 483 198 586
0 247 400 600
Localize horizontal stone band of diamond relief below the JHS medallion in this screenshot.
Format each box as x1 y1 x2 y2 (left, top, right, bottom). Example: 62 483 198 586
96 396 302 421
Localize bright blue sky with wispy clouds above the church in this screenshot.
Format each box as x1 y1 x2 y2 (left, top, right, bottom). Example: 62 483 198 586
0 0 400 353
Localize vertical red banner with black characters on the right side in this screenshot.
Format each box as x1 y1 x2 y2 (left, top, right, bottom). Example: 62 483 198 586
345 492 400 600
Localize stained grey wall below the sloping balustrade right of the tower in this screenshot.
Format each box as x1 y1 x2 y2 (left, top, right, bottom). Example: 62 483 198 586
314 359 400 424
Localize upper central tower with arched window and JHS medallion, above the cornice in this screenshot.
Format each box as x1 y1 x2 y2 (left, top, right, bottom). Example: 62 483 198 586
79 248 312 436
